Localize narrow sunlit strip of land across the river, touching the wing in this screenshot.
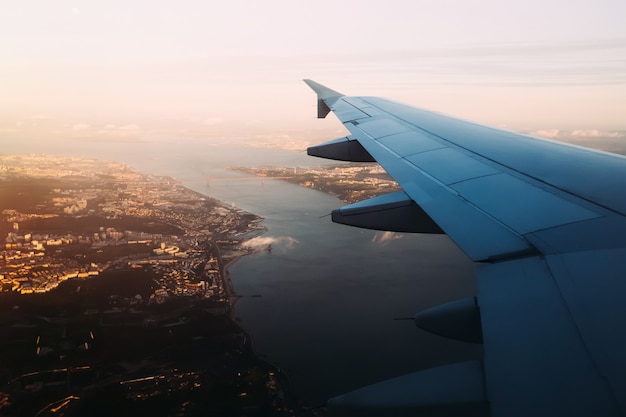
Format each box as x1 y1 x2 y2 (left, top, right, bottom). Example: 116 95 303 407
232 163 401 203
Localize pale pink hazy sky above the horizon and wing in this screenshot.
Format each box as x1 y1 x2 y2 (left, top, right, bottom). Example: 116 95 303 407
0 0 626 152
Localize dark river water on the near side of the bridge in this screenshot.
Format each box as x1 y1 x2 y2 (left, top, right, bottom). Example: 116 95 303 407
211 181 476 402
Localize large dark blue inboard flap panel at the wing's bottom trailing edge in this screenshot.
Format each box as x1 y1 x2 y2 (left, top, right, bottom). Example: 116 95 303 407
477 257 623 416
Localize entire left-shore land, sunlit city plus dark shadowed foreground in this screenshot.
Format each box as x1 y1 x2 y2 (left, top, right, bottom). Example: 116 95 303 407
0 155 312 416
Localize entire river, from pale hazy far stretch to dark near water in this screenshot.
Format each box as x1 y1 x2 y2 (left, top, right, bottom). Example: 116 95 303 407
2 136 480 403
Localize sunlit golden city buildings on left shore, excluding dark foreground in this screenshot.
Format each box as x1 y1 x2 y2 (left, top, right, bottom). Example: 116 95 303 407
0 156 262 298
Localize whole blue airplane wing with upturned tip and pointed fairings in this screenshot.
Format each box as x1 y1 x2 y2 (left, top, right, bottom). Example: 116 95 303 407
304 80 626 416
